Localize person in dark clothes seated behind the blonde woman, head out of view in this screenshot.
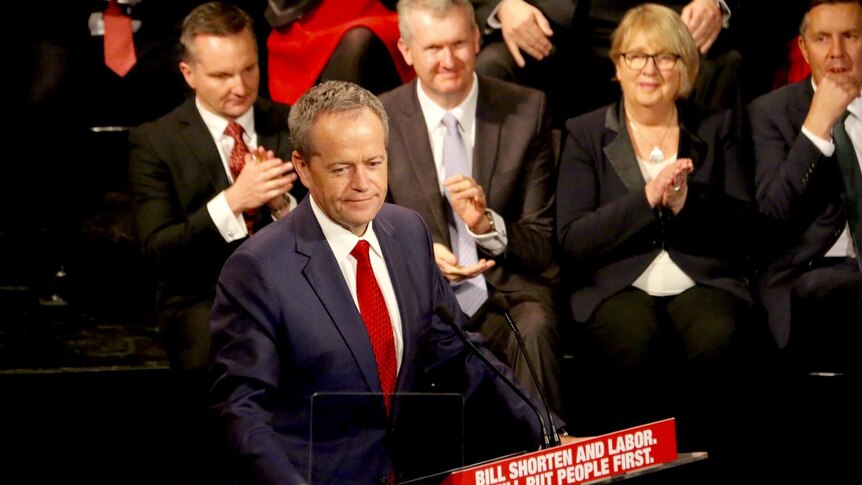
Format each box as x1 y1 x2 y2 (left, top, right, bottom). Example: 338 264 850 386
476 0 741 126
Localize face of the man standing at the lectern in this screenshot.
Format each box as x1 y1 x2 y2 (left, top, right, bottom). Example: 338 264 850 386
293 109 387 236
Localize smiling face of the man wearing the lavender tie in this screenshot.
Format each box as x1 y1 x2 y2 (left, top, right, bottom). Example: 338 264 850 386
398 7 479 108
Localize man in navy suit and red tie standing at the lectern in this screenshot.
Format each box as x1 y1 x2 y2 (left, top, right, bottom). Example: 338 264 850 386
211 81 560 485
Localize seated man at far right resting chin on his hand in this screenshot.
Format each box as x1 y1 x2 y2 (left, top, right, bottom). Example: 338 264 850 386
748 0 862 370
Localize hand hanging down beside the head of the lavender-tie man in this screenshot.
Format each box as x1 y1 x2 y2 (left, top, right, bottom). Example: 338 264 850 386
497 0 554 67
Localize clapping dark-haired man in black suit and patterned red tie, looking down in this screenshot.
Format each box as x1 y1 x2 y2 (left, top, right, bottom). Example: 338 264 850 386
129 3 304 483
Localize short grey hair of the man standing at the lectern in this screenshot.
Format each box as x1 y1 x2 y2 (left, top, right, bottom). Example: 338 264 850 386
287 81 389 160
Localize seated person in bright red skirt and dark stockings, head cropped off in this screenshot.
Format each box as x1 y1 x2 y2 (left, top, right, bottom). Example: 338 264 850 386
265 0 413 104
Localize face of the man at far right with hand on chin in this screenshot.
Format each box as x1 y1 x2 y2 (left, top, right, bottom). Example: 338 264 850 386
799 2 862 84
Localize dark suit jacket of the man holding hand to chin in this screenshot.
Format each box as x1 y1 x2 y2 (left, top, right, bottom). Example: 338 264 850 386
748 77 847 347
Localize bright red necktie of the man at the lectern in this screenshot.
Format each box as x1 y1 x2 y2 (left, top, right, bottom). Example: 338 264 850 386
350 240 397 414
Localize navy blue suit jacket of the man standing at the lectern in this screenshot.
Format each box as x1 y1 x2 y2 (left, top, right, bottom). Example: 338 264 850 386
211 200 552 485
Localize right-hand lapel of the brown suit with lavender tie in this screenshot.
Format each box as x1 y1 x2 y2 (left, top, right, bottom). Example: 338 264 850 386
473 77 505 191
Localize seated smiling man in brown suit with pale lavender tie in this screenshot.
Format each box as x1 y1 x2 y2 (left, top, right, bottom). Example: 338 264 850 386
381 1 562 411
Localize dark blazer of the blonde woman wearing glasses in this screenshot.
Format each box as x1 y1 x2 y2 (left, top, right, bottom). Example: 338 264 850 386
557 103 754 322
